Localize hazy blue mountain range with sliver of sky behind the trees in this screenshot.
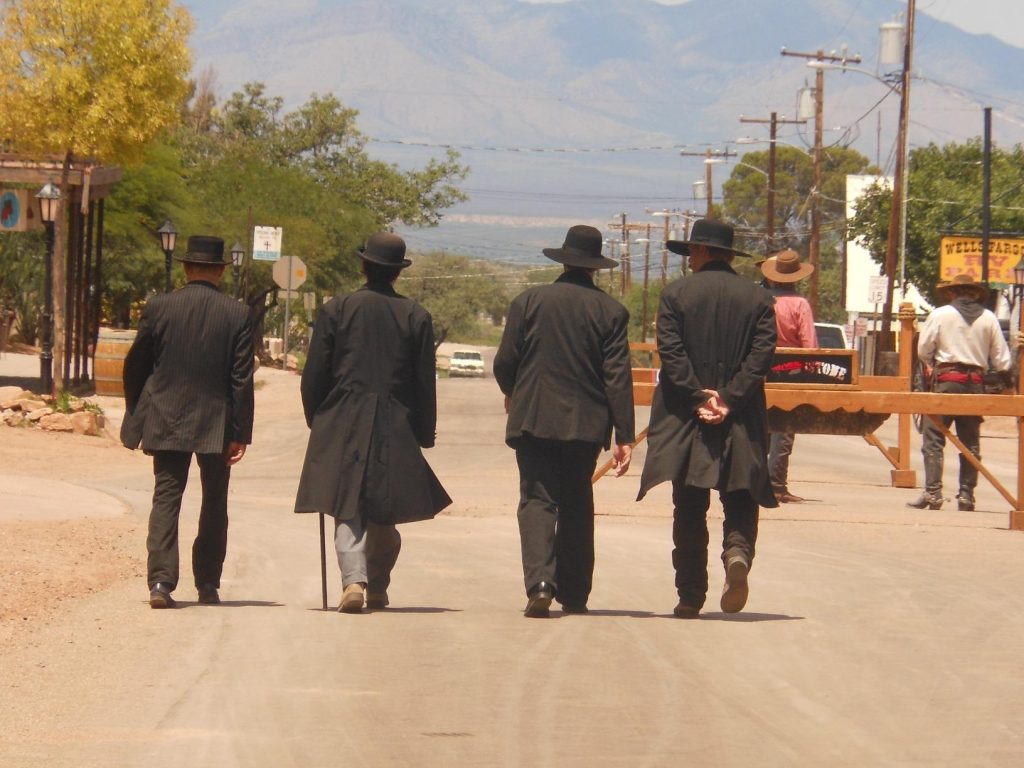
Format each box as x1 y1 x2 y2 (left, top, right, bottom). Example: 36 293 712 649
184 0 1024 264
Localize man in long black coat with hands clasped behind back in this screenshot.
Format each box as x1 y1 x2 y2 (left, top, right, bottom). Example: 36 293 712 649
638 219 776 618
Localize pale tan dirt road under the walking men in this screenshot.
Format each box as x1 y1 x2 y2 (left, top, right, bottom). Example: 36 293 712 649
0 362 1024 768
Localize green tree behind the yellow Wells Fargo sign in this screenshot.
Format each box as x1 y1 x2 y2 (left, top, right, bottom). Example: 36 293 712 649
850 139 1024 303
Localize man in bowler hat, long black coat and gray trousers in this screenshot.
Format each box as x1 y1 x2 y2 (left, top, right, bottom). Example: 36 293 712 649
295 232 452 613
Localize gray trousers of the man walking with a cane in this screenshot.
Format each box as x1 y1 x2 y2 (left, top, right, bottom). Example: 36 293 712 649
334 514 401 594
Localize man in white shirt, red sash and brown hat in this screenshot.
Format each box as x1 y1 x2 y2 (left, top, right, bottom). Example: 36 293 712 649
907 274 1010 512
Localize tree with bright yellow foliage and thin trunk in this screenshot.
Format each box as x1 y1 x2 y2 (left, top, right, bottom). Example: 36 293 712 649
0 0 191 387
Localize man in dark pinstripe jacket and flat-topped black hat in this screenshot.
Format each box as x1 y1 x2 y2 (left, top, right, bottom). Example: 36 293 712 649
121 236 253 608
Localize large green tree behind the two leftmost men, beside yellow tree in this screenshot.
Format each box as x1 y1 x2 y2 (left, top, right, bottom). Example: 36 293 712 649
178 78 468 303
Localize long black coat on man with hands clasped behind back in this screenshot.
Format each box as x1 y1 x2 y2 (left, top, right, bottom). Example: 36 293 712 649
637 260 777 507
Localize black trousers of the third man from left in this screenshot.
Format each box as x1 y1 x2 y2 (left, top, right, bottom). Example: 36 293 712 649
515 437 600 605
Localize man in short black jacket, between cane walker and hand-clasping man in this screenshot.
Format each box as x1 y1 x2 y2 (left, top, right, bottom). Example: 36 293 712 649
495 225 634 617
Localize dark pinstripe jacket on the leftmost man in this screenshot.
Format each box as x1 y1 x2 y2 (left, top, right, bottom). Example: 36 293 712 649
121 281 253 454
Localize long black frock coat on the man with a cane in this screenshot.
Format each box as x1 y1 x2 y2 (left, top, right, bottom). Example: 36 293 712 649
295 284 452 524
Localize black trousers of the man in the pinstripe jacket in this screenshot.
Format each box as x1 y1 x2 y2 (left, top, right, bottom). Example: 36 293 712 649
145 451 231 589
